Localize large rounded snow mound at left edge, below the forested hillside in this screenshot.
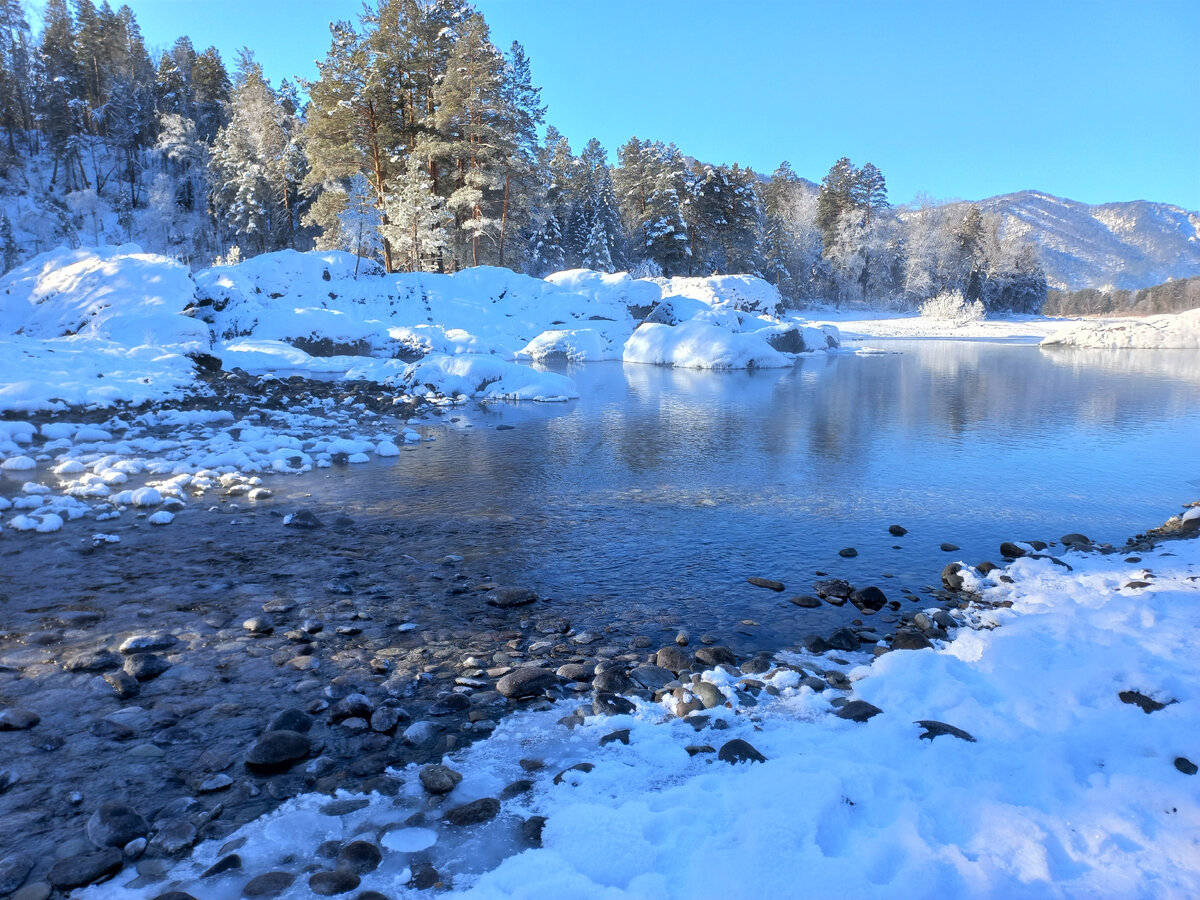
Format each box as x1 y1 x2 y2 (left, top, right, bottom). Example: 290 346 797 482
0 244 209 350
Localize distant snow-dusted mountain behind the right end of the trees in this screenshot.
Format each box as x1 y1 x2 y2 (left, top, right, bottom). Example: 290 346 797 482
976 191 1200 290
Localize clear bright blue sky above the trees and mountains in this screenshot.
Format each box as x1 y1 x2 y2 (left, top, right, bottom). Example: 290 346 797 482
60 0 1200 210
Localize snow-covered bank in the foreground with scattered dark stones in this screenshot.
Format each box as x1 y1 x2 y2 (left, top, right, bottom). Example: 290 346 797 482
80 532 1200 900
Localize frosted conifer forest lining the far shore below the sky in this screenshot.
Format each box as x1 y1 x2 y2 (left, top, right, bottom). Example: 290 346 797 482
0 0 1046 312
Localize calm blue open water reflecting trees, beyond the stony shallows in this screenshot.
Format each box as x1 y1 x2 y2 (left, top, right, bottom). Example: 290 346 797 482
295 341 1200 649
